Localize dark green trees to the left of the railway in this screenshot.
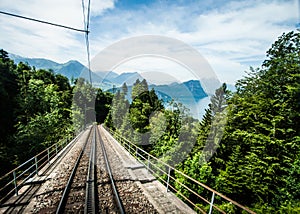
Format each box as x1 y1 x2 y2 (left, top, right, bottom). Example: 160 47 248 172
0 49 112 177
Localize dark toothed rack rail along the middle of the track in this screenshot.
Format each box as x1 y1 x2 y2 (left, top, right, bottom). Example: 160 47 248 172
84 124 97 214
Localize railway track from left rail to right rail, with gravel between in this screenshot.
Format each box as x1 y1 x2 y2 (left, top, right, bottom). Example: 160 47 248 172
56 126 125 214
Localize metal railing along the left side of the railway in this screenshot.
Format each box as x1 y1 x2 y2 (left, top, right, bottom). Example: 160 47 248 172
0 132 82 206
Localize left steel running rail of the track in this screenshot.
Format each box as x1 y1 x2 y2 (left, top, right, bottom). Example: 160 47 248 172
56 128 92 214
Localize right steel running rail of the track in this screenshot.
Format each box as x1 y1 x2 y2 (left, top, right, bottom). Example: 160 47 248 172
97 128 125 214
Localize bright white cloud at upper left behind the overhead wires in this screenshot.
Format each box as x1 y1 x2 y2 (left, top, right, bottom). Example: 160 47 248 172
0 0 113 64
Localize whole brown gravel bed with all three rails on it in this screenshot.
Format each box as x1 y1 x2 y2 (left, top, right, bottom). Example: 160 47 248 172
15 125 157 213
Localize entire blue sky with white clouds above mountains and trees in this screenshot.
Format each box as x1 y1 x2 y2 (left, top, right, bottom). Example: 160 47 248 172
0 0 299 83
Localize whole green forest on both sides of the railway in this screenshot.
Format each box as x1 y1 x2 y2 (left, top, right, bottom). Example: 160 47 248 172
0 31 300 213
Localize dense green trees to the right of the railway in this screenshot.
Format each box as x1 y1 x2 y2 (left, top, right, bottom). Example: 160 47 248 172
106 32 300 213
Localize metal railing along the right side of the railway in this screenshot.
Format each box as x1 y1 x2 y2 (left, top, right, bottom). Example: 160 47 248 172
106 128 255 214
